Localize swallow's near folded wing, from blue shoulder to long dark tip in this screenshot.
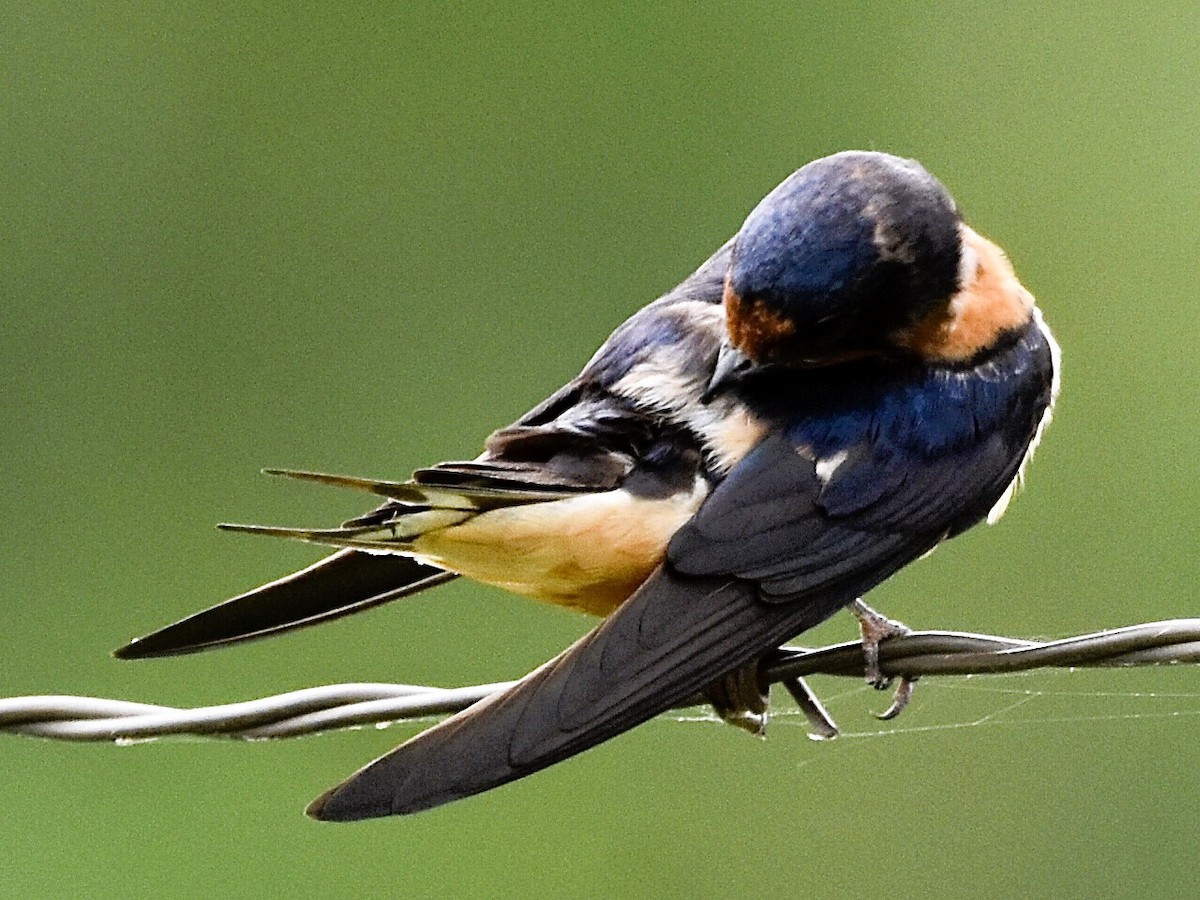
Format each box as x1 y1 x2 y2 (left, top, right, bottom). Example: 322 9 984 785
308 340 1044 821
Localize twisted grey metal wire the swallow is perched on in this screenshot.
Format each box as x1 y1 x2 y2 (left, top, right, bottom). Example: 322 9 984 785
0 619 1200 743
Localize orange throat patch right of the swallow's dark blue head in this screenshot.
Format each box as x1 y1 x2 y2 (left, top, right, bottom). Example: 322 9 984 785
893 226 1033 362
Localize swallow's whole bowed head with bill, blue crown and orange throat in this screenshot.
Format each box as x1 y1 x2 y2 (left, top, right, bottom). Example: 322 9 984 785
714 151 1032 396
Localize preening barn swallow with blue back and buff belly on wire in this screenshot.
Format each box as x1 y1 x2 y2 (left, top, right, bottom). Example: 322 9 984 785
116 152 1060 821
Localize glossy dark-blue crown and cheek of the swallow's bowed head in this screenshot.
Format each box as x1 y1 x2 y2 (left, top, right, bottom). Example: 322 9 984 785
726 152 960 361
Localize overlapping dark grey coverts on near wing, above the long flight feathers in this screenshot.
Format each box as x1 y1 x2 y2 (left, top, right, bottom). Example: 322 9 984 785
667 434 1024 604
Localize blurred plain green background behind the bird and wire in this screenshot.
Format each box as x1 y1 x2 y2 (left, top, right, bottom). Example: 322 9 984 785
0 0 1200 898
